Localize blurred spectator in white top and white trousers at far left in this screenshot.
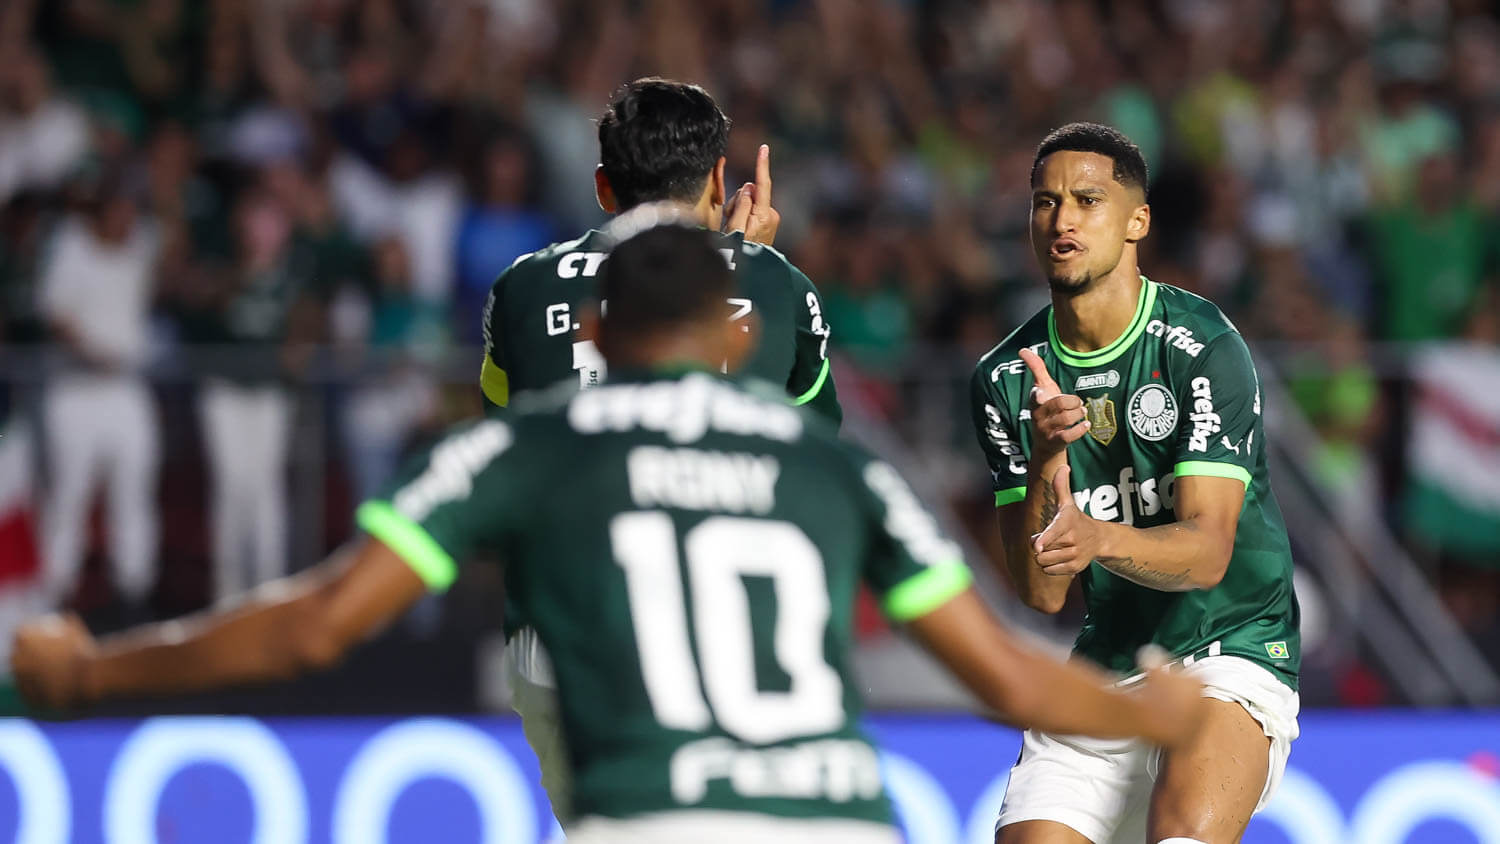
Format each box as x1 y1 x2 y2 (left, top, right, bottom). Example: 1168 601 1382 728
41 178 161 610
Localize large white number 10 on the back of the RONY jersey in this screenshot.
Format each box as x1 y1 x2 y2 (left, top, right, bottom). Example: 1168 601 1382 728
609 511 845 744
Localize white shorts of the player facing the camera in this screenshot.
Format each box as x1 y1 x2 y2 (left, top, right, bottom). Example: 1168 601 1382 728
995 657 1301 844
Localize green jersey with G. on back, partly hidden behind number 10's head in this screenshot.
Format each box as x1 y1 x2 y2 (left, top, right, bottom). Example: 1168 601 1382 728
480 231 842 423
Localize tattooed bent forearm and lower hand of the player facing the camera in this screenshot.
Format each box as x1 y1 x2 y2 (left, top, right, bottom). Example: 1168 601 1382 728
1032 468 1245 592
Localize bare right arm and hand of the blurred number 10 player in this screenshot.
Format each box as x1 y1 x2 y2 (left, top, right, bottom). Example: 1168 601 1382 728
908 589 1205 747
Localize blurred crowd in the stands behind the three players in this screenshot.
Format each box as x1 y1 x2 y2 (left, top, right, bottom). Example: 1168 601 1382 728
0 0 1500 710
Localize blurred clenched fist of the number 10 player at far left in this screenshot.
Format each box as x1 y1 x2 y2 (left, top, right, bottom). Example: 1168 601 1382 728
11 613 95 709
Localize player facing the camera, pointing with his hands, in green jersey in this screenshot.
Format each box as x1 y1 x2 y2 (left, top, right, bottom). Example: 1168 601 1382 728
972 123 1299 844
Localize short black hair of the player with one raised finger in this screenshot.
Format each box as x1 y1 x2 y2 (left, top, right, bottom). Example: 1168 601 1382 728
599 76 729 208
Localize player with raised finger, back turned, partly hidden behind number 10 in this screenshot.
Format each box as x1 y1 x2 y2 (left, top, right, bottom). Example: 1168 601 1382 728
480 76 842 825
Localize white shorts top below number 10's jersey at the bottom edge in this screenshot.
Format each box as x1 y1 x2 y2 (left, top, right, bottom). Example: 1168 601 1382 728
567 810 902 844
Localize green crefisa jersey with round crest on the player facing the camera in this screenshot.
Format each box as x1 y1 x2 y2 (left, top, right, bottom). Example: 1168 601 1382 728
971 279 1301 690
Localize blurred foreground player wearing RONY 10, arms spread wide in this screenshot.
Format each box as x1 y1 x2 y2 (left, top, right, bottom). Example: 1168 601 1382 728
12 225 1206 844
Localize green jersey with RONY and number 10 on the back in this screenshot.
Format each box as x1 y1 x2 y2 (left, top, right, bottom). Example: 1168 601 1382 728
359 373 971 822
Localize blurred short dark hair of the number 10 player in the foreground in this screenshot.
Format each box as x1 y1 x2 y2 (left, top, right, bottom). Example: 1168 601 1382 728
599 223 734 334
